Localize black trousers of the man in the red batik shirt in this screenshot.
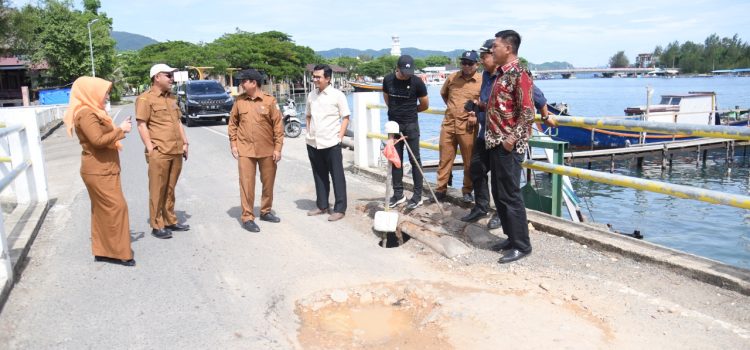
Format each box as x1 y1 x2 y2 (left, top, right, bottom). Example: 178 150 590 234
487 145 531 253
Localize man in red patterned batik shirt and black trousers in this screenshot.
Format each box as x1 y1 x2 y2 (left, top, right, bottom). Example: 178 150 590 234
480 30 534 264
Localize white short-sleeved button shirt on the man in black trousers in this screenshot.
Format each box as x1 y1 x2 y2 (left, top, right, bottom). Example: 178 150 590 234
305 86 351 149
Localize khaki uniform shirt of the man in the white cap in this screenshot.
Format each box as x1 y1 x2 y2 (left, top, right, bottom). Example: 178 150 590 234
135 87 183 154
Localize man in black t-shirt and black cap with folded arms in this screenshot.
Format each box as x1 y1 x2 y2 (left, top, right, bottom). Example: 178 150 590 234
383 55 429 210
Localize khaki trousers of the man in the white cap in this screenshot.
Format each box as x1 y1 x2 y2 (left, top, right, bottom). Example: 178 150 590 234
146 150 182 229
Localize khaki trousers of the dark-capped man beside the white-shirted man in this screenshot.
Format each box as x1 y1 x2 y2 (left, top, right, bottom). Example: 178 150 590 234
237 156 276 222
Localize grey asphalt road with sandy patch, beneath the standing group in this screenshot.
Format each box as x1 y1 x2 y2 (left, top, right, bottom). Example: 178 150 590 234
0 100 750 349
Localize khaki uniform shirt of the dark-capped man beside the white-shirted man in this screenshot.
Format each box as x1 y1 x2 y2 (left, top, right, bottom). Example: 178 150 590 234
228 93 284 158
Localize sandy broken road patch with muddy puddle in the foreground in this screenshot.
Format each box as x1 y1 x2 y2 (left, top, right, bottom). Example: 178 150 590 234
295 281 614 350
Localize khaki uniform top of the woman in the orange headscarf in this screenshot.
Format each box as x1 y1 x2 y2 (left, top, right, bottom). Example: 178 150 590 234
75 108 125 175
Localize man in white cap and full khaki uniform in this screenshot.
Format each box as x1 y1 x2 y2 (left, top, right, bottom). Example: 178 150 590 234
135 64 190 239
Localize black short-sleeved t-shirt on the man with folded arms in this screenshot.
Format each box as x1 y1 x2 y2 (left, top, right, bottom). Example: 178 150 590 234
383 73 427 123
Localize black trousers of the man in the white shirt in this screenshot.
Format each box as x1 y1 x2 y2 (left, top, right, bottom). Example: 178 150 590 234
307 144 346 213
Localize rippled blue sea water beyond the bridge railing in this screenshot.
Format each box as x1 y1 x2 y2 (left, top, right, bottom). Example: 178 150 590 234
342 77 750 268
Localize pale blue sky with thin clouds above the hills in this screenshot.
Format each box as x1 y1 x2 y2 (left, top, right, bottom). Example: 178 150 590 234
11 0 750 67
